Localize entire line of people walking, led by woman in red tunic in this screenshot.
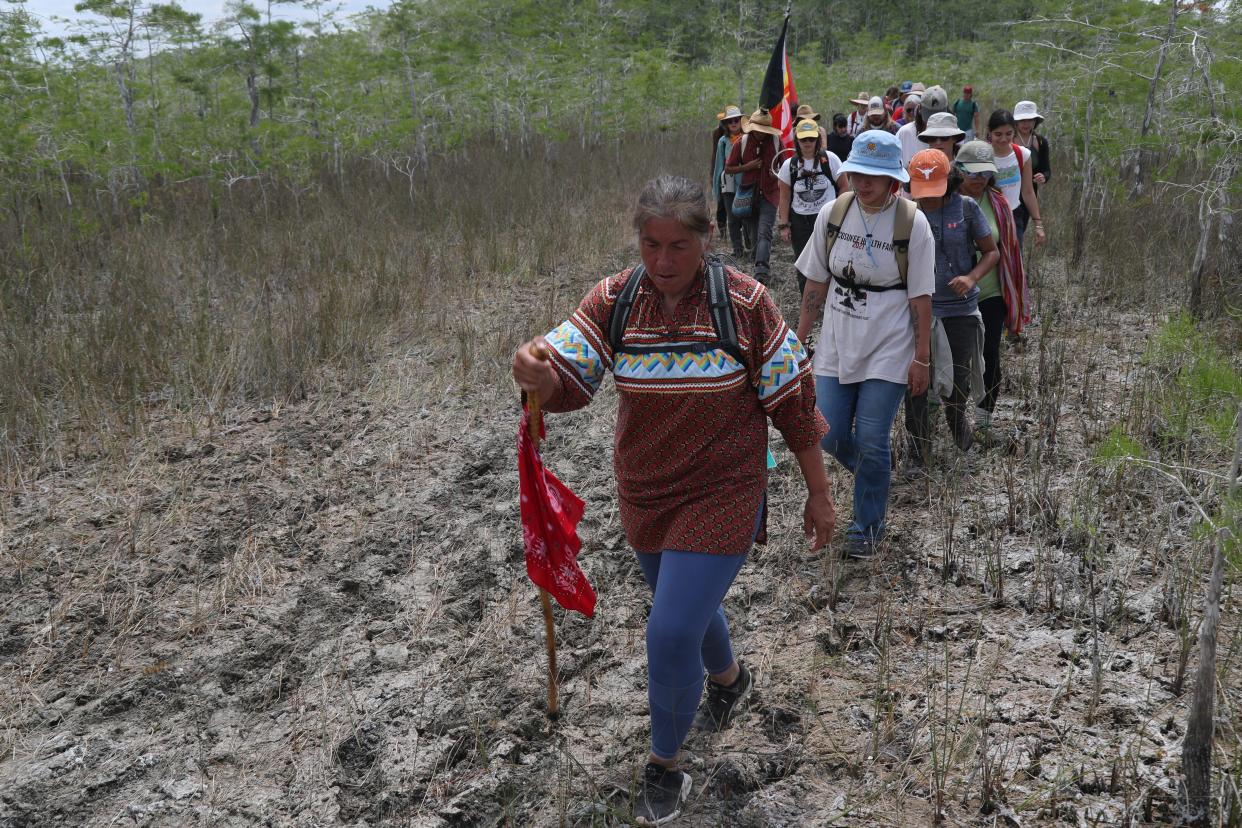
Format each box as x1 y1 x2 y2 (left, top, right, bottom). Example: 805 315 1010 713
513 83 1051 826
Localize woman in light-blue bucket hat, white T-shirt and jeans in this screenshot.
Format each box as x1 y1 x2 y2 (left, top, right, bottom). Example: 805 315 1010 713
797 129 935 559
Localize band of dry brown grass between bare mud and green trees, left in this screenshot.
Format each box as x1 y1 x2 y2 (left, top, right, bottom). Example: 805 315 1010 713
0 135 688 473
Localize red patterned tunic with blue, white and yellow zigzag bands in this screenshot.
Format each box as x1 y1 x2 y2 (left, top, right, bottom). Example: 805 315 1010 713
544 268 828 555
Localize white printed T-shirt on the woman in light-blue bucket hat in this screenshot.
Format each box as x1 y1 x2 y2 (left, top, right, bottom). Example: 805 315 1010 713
796 201 935 385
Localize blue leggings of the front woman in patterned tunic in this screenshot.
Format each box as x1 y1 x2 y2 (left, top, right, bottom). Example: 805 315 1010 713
636 550 746 758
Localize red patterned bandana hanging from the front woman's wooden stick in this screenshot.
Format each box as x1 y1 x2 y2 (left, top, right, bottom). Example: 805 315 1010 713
518 410 595 617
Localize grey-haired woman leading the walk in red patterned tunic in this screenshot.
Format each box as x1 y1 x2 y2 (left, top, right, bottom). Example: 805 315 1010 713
513 176 835 826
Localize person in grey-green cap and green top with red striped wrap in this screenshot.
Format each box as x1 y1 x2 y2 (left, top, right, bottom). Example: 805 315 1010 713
954 140 1031 433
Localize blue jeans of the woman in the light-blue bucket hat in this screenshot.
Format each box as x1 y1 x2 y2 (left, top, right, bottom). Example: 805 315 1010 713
815 375 905 541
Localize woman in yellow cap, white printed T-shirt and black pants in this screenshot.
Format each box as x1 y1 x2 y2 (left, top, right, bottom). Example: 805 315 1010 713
776 119 846 294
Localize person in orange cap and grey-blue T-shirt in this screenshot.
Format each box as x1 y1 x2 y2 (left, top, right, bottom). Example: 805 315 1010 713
905 147 1000 469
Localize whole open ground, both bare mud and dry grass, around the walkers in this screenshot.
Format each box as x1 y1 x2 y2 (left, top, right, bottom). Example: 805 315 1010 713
0 130 1242 826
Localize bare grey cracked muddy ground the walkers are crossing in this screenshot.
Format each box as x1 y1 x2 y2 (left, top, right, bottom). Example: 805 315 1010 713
0 243 1233 828
